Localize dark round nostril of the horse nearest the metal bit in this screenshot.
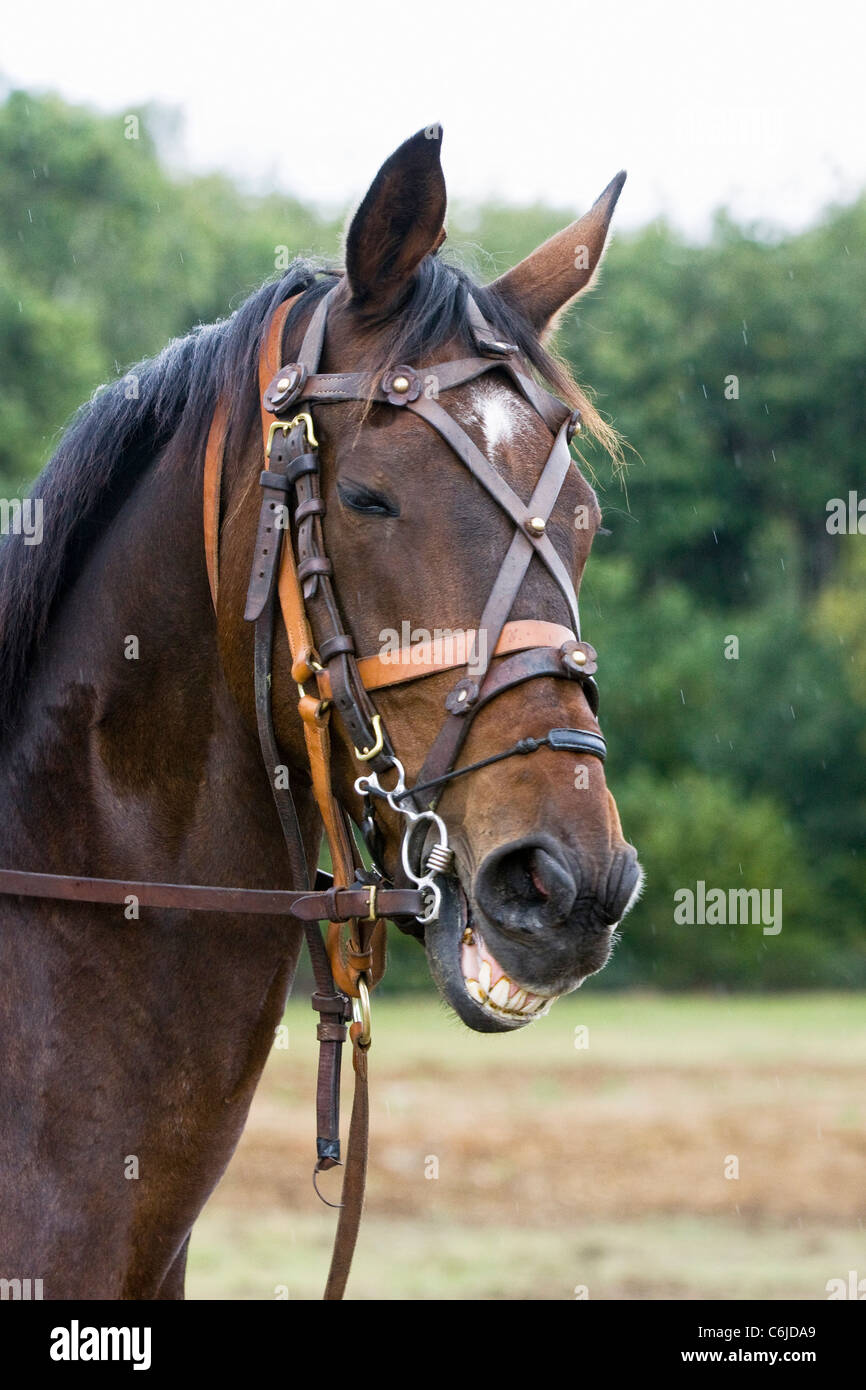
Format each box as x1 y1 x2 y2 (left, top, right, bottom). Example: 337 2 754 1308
475 840 578 937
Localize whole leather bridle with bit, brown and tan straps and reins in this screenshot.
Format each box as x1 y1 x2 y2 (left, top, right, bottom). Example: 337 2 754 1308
0 273 606 1298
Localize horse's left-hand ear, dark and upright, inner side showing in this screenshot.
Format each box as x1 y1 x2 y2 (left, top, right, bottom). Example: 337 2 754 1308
346 125 446 310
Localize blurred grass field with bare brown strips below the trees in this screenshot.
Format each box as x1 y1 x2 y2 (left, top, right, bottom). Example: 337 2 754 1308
188 994 866 1300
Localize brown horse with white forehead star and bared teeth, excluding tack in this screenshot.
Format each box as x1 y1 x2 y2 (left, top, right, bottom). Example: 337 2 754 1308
0 128 641 1298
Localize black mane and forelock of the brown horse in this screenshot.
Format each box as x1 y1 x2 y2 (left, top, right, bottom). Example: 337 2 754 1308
0 256 580 731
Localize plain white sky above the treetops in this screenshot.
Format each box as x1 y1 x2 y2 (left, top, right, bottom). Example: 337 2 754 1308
0 0 866 235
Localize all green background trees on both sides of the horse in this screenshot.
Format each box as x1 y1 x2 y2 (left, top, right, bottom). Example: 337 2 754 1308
0 92 866 988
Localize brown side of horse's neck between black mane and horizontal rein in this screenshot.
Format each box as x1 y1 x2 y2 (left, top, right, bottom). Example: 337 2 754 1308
3 439 310 885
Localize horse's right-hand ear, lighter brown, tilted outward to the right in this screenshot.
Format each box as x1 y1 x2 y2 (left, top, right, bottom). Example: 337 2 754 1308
491 170 626 332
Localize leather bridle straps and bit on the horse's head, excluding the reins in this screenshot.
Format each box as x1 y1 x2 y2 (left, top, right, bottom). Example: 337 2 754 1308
233 285 606 906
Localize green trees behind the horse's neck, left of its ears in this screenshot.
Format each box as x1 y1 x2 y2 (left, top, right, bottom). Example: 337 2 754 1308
0 92 338 491
